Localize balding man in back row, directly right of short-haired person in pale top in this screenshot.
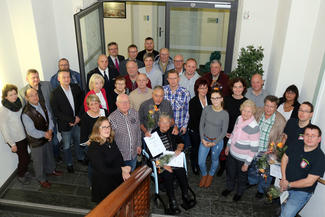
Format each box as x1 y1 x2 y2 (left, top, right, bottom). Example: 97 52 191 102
154 48 175 85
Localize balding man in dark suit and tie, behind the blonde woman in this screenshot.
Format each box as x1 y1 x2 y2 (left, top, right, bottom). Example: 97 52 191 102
87 54 119 100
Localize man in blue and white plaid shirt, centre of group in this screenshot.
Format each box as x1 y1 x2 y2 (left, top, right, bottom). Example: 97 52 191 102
164 70 191 149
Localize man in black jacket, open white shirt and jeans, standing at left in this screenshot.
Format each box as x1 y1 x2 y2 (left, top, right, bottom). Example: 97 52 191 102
50 70 84 173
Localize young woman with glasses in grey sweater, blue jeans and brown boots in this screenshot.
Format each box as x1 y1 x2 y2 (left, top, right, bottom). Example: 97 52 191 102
199 90 229 188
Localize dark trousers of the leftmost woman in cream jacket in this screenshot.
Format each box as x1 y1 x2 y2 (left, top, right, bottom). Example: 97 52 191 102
16 139 30 177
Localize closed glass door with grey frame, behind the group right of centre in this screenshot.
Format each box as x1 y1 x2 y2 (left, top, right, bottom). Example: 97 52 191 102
166 1 237 73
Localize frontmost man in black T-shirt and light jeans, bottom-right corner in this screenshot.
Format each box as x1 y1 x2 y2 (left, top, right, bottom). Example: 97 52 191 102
280 124 325 217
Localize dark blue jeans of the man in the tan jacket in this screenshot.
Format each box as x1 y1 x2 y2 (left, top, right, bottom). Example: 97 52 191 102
248 159 273 193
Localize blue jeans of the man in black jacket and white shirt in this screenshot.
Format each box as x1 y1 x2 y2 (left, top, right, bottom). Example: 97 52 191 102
61 125 85 166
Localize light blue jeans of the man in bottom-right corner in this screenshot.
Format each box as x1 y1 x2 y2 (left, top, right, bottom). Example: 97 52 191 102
280 190 312 217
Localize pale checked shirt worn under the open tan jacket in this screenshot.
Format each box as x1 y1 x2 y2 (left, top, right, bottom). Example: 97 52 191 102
258 113 275 152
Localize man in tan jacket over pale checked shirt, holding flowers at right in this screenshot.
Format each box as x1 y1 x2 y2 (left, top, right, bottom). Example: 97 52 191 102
248 95 286 199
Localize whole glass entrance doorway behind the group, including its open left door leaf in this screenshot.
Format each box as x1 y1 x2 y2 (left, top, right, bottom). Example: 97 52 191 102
75 0 238 87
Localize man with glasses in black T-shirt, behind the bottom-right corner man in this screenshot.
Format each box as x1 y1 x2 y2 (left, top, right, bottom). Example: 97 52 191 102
282 102 314 146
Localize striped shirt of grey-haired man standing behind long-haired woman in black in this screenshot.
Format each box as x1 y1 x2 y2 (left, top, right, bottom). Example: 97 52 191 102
108 108 141 161
